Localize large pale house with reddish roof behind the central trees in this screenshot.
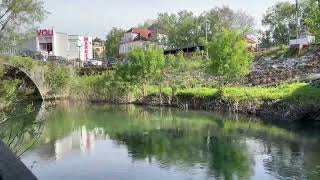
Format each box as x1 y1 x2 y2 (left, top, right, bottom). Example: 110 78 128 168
119 28 167 55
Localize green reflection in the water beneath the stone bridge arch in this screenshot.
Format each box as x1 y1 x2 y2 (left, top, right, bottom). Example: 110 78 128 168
0 103 47 157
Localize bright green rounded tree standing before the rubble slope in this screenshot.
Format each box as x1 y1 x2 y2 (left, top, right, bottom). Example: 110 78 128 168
208 30 252 83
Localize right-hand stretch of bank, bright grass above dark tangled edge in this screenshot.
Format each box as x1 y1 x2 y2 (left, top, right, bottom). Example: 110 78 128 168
129 83 320 121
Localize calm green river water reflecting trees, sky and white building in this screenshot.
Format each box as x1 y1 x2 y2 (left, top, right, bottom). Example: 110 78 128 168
0 104 320 180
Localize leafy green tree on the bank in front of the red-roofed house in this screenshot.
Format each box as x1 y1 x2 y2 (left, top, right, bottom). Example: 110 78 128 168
116 47 165 96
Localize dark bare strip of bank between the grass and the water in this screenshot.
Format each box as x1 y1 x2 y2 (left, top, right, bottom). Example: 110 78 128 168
44 95 320 122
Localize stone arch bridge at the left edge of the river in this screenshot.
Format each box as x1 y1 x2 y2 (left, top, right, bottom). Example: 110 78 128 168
0 62 50 100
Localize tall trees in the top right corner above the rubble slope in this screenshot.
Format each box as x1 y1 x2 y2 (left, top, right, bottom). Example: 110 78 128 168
259 0 320 48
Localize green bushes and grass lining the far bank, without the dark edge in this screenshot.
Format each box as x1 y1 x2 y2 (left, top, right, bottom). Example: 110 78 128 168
2 55 320 107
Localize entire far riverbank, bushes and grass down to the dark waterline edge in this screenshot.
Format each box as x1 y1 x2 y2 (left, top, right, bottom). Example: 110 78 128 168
2 55 320 121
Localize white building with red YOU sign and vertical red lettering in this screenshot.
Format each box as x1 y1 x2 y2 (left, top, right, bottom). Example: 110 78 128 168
23 29 93 61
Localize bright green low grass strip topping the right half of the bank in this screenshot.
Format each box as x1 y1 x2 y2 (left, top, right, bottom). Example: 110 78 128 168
147 83 320 104
